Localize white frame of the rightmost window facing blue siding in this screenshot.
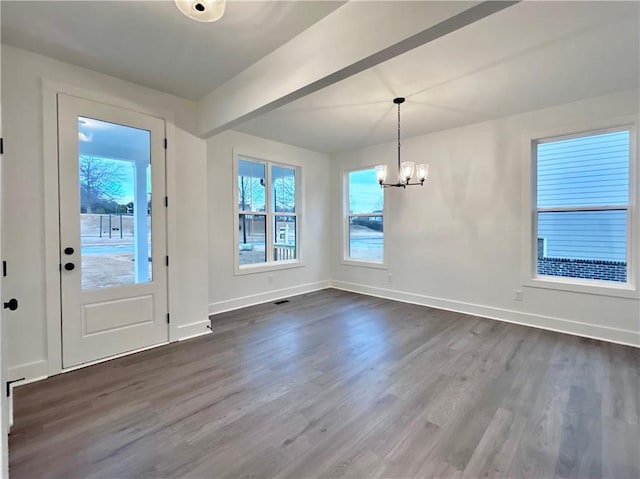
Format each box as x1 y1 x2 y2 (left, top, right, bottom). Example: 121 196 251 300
522 116 640 299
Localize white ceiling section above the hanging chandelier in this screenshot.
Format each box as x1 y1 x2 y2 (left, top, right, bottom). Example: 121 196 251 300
236 1 640 153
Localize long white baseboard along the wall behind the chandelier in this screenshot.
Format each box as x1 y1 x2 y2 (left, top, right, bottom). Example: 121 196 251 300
331 281 640 347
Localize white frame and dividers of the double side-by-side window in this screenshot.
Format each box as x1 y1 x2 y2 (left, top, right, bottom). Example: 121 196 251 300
232 149 304 276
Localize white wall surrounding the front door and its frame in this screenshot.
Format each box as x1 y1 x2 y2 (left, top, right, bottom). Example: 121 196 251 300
2 45 207 378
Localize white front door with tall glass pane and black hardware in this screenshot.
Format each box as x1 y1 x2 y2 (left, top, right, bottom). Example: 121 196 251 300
58 94 169 368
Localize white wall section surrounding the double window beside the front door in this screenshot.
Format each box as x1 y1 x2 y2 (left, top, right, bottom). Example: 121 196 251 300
207 131 331 314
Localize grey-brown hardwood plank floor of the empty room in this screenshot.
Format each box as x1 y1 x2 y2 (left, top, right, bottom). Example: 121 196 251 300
10 290 640 479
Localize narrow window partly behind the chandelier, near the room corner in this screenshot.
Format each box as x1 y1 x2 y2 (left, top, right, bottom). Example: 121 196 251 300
344 168 384 264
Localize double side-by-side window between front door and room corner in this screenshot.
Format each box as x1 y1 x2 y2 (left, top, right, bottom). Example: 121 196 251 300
236 156 300 270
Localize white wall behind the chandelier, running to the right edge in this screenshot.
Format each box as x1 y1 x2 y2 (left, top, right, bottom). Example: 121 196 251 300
331 90 640 344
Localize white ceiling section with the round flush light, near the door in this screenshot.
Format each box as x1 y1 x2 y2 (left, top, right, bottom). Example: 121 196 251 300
0 0 344 100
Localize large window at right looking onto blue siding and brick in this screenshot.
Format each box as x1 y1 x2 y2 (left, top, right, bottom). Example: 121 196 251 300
533 128 632 284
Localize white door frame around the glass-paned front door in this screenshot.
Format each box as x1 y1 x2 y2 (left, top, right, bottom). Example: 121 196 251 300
42 79 178 376
